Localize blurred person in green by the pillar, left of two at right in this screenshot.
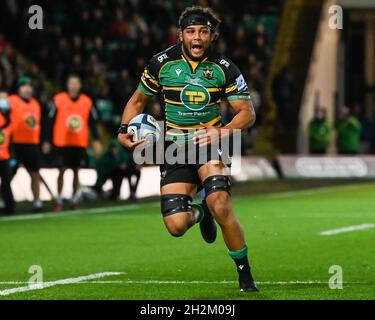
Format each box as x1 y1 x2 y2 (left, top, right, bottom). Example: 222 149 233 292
309 107 331 154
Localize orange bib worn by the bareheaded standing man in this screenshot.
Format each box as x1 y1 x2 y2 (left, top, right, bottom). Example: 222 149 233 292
53 92 92 148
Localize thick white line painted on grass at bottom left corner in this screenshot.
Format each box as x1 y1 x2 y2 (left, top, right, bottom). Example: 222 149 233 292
0 272 123 296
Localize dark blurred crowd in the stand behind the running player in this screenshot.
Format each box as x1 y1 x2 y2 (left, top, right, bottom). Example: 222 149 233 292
0 0 281 125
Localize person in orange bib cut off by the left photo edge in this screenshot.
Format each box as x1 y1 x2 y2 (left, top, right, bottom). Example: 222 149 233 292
0 91 15 214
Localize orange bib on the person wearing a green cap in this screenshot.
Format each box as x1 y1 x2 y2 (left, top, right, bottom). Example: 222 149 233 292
8 94 41 144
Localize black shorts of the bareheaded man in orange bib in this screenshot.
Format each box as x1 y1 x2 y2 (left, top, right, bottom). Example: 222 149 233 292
56 147 87 169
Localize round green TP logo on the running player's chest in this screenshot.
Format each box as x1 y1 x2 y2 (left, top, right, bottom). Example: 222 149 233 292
180 84 211 111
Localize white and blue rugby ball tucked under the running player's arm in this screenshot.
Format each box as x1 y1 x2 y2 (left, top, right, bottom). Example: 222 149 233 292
128 113 161 143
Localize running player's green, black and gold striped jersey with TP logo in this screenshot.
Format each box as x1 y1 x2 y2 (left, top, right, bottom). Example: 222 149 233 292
139 44 251 142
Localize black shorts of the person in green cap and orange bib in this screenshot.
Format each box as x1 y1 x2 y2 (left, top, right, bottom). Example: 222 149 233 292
13 143 41 172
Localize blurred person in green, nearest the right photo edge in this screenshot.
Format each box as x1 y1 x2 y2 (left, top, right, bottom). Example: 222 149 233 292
336 107 362 155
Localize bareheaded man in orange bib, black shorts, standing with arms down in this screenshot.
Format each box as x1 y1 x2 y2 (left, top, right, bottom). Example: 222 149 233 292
43 75 101 211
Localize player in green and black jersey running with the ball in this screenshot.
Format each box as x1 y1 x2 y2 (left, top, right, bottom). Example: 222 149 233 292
118 6 258 292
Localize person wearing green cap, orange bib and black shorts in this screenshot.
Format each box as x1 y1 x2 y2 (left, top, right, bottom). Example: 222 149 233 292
9 76 43 212
